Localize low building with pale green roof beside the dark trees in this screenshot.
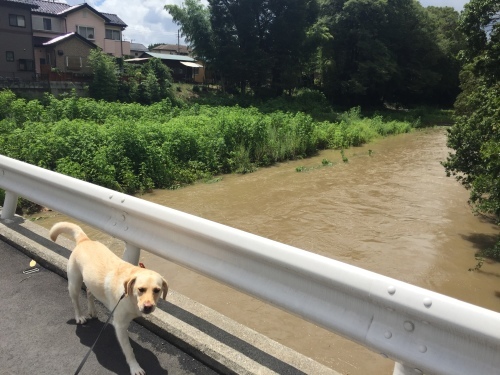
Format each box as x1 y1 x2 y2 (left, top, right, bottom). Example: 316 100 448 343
125 52 204 83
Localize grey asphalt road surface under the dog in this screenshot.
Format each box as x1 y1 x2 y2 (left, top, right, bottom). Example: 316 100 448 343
0 241 216 375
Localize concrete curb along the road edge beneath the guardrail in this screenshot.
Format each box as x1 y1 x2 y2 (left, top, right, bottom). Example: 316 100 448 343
0 216 339 375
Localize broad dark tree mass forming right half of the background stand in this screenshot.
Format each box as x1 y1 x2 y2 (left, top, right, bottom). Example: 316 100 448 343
320 0 458 105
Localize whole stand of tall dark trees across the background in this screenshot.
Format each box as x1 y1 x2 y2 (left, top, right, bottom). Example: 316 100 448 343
165 0 464 107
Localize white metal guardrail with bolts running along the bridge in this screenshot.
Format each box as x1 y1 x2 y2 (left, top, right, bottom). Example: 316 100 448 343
0 155 500 375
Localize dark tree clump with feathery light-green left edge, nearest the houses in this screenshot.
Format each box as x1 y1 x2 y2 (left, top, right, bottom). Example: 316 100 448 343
165 0 318 95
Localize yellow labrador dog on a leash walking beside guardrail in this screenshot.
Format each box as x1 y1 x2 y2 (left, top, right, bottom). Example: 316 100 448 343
50 222 168 375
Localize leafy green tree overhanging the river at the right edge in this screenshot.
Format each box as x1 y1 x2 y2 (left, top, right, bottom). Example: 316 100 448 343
443 0 500 259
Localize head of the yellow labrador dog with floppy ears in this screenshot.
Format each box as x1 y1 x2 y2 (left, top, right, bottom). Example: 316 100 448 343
124 269 168 314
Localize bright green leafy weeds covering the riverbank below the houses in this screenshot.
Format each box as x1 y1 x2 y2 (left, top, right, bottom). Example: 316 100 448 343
0 91 412 194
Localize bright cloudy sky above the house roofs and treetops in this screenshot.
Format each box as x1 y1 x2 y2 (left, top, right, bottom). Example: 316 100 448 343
65 0 468 47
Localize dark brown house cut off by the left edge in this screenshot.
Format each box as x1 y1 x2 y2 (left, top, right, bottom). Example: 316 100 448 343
0 0 35 82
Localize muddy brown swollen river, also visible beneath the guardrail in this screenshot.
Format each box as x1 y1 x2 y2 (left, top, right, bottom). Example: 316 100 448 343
31 128 500 375
